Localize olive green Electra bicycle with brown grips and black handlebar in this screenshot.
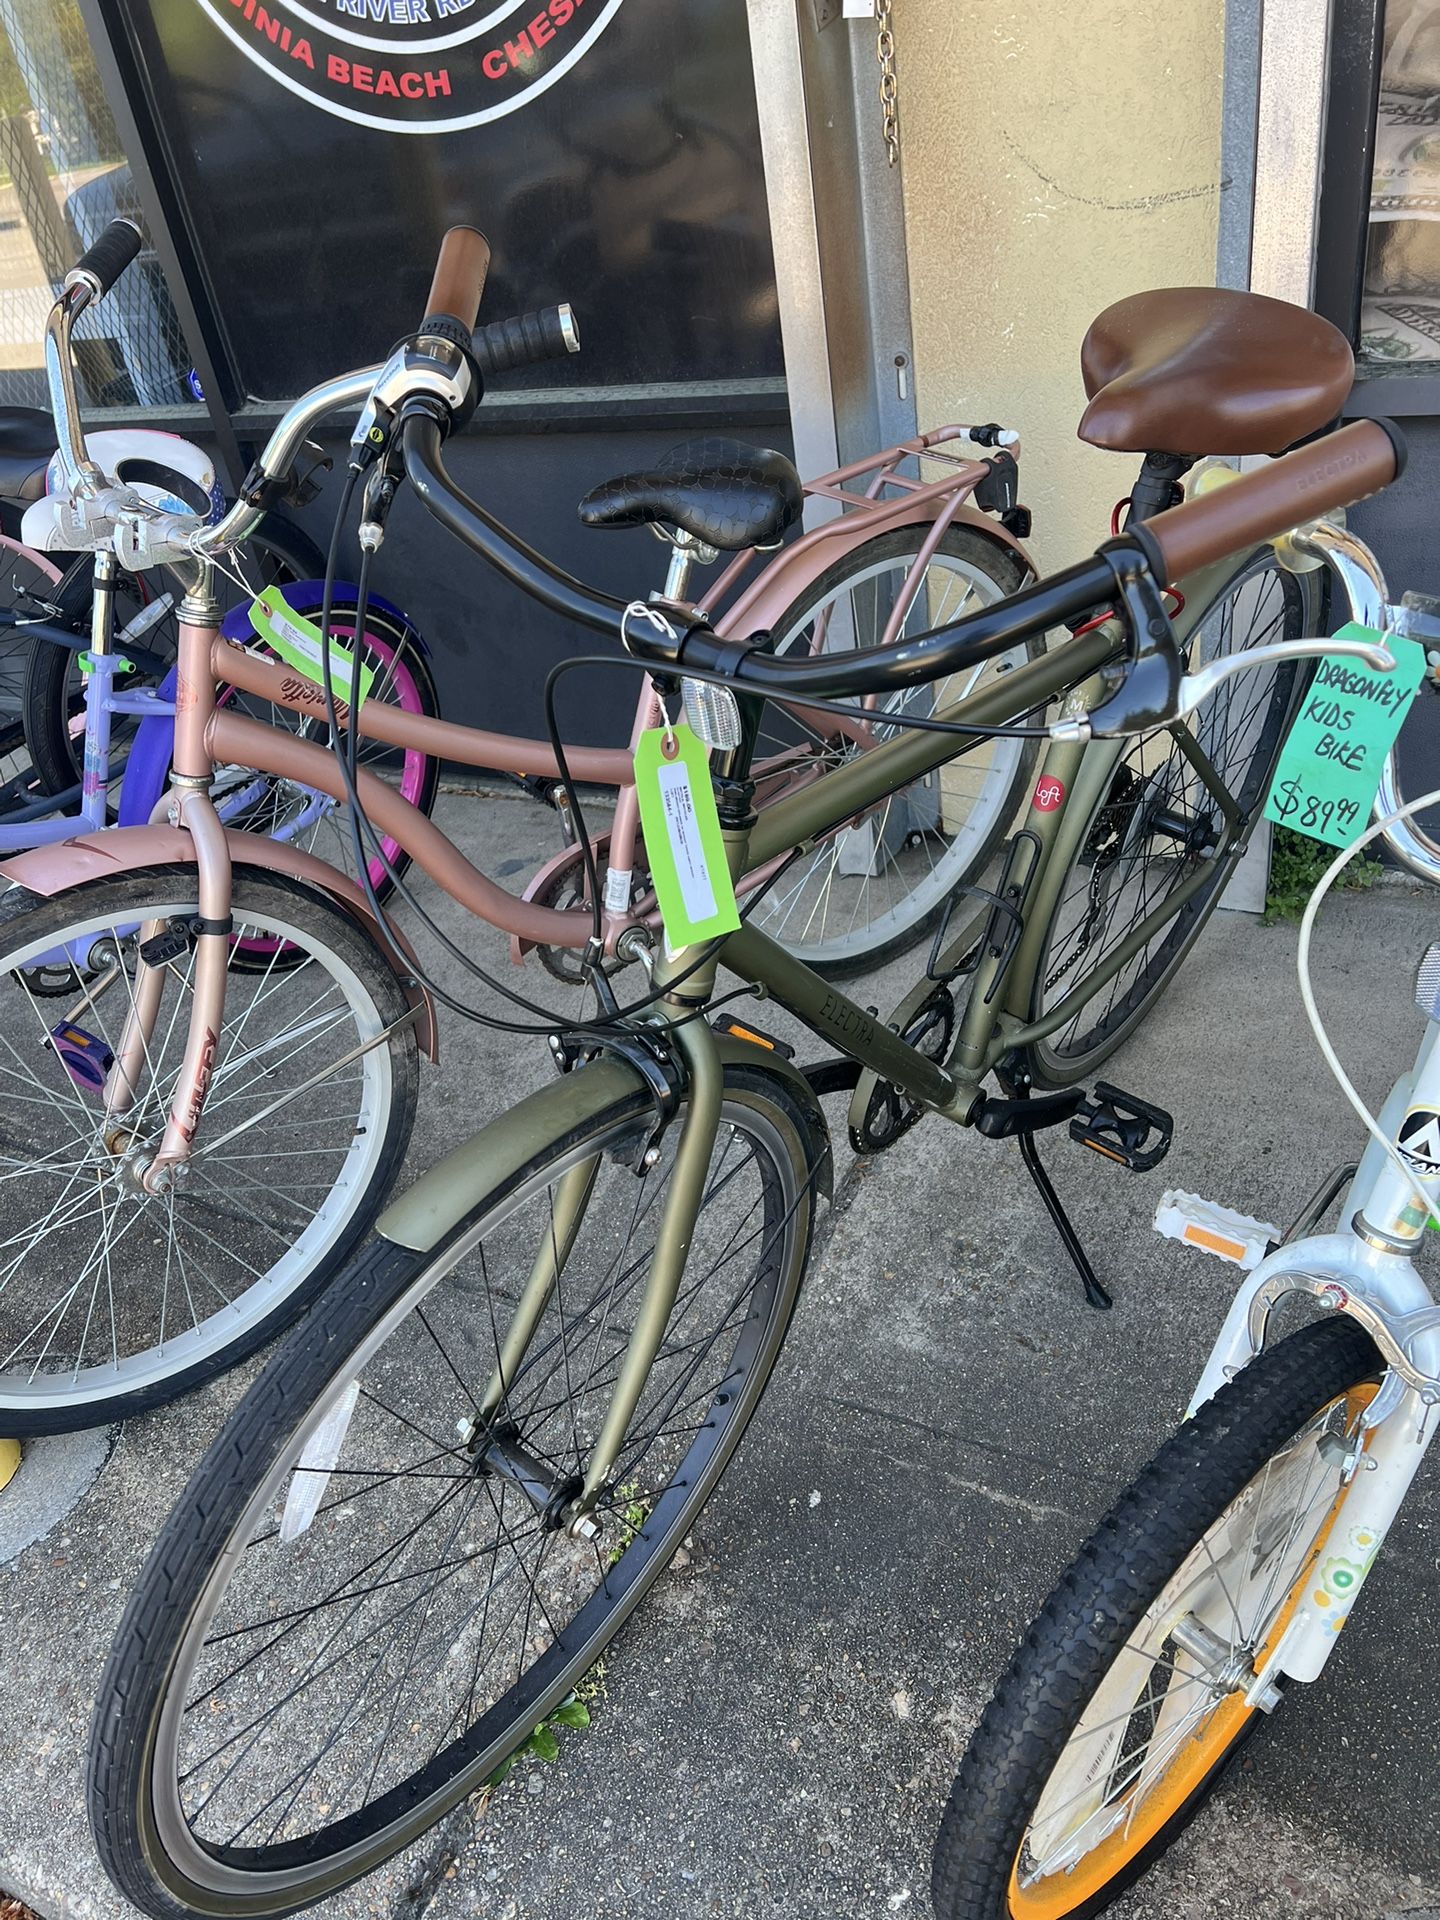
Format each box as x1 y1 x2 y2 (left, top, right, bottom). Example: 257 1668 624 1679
90 243 1398 1920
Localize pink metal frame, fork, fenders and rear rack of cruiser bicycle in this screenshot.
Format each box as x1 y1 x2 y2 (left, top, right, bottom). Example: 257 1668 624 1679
0 428 1036 1192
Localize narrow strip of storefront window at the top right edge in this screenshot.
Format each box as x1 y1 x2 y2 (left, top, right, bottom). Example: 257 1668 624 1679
1359 0 1440 372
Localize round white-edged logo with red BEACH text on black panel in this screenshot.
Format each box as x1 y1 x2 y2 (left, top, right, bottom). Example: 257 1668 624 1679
196 0 622 132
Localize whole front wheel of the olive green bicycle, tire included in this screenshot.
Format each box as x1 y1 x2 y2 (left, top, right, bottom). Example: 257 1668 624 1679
90 1068 822 1920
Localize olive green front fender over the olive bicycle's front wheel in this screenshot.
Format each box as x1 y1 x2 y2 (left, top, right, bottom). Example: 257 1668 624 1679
376 1033 831 1254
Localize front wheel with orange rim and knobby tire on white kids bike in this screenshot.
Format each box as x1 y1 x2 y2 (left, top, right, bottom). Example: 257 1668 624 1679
933 1319 1380 1920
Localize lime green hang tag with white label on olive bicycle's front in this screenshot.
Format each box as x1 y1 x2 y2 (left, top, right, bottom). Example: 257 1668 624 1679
636 724 739 954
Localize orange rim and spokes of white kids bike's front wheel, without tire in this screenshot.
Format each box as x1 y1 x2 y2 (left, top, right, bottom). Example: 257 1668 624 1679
1008 1382 1377 1920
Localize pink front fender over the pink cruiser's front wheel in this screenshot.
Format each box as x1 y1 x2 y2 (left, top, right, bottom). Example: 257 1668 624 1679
0 826 440 1060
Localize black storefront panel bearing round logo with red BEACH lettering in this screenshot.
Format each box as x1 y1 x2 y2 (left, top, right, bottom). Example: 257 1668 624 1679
121 0 783 401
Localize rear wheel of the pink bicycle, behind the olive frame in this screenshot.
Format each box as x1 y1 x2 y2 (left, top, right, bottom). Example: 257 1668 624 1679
753 526 1044 979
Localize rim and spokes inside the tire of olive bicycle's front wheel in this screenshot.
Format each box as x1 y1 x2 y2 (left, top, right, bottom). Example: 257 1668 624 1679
152 1102 804 1895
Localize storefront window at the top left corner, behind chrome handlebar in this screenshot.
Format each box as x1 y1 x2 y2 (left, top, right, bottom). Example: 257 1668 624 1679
0 0 196 413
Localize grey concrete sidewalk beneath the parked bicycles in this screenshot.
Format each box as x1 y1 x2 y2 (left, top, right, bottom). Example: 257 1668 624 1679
0 799 1440 1920
